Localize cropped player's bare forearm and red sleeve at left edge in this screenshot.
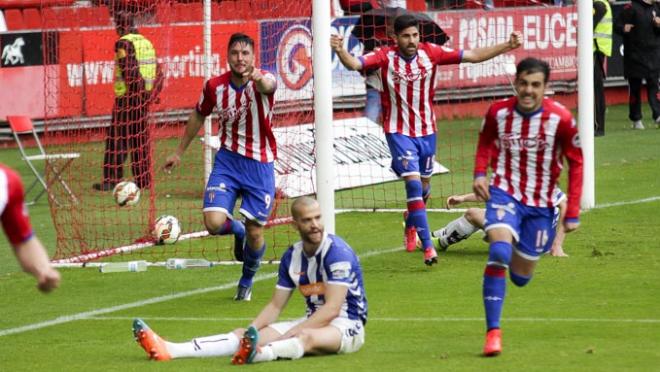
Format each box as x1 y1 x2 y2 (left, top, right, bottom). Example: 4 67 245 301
0 163 60 293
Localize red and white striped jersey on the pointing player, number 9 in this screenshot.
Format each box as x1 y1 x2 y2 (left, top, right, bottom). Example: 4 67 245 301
196 70 277 163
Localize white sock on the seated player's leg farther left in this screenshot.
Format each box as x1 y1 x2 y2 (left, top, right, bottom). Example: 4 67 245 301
165 332 239 358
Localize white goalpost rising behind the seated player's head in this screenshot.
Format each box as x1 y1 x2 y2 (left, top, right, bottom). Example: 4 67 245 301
312 0 335 234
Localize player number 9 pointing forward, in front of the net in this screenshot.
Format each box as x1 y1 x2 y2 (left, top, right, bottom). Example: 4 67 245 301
163 33 277 301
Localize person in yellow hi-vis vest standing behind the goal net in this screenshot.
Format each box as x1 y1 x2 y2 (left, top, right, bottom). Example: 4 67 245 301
93 11 162 191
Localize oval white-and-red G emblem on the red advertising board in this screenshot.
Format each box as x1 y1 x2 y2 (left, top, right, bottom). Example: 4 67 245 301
277 25 312 90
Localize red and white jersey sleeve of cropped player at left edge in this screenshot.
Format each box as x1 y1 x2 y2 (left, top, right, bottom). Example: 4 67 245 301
0 164 32 246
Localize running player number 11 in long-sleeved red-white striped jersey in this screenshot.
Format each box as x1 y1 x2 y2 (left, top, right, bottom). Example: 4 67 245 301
473 58 582 356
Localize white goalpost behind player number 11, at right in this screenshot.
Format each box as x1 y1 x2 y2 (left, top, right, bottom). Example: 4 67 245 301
577 0 596 209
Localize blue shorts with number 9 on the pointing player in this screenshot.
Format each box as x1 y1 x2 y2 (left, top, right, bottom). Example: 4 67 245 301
204 149 275 225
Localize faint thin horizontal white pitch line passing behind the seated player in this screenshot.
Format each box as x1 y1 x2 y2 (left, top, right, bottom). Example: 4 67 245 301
84 316 660 324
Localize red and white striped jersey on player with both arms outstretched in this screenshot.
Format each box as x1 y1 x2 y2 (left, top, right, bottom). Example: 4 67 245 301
359 42 463 137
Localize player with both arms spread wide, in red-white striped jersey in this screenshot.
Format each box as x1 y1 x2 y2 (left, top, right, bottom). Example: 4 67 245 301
330 14 521 265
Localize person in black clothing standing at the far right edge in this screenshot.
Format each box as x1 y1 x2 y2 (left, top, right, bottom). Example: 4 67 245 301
614 0 660 129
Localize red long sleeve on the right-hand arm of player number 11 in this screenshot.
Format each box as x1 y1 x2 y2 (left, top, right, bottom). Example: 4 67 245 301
557 112 582 222
